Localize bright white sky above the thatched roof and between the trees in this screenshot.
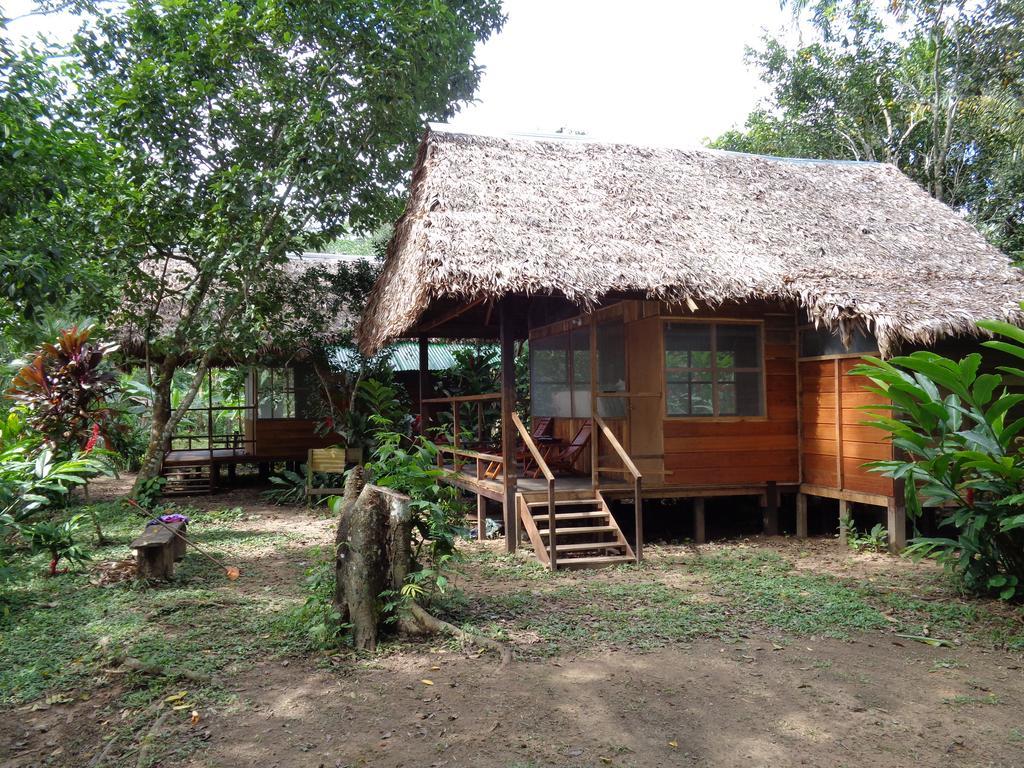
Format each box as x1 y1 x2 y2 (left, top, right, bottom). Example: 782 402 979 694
0 0 793 146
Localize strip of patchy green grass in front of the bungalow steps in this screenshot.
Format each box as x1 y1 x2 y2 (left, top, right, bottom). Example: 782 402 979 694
450 548 1024 655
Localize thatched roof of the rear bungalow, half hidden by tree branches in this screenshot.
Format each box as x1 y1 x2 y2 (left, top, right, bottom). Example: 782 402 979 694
111 252 379 359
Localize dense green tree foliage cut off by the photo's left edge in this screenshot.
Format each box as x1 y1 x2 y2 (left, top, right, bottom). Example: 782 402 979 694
0 20 109 354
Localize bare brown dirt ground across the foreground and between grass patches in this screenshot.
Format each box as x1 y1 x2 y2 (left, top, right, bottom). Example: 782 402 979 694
0 490 1024 768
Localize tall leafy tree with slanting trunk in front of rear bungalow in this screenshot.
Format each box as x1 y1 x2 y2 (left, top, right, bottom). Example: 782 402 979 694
27 0 504 489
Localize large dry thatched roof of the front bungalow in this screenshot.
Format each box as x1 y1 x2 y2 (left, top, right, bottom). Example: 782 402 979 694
357 126 1024 353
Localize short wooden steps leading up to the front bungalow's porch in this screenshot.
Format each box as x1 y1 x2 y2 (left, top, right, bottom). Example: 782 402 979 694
516 492 636 568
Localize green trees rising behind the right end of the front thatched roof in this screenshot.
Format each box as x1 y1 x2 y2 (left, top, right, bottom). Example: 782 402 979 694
712 0 1024 258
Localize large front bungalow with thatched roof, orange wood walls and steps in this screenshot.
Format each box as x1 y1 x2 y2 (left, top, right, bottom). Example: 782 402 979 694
357 126 1024 567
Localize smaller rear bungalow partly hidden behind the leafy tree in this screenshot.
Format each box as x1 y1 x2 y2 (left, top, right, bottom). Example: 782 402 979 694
117 253 372 494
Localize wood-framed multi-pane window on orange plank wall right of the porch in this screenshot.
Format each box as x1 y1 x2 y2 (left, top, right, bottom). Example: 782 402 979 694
665 323 763 416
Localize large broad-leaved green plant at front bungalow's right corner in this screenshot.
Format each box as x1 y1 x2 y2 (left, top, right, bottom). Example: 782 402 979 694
853 322 1024 600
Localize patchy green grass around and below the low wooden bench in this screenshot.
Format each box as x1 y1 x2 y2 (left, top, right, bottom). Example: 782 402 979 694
0 505 301 707
